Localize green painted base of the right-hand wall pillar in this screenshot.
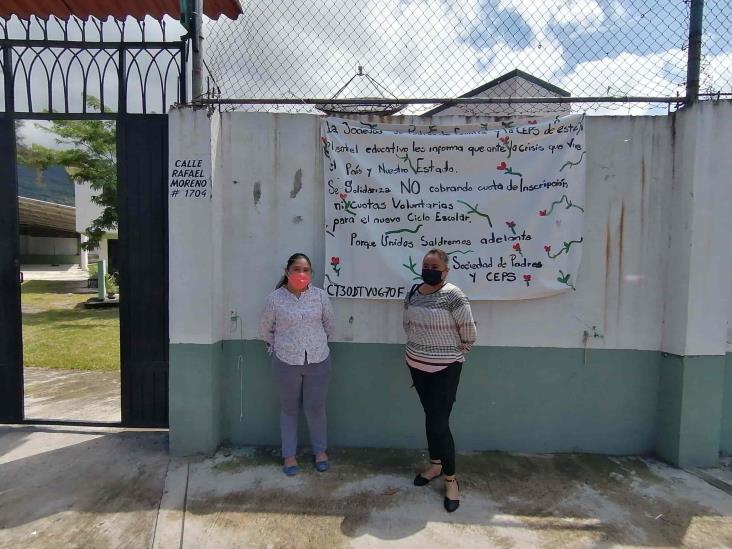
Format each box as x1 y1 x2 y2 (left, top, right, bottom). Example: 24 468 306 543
656 354 725 467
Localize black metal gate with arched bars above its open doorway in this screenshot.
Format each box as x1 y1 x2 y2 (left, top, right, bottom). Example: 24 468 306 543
0 19 186 427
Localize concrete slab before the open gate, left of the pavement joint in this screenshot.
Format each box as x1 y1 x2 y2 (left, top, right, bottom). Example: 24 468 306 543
0 427 168 548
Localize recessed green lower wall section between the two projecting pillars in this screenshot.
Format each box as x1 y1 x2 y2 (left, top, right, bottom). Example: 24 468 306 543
214 341 658 454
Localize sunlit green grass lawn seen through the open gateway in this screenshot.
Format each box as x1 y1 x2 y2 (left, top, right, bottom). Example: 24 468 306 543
21 280 119 370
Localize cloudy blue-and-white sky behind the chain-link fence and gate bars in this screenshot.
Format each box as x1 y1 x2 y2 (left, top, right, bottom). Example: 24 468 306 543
7 0 732 148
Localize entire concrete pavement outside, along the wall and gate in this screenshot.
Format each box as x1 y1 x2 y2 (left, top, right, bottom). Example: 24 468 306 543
0 427 732 549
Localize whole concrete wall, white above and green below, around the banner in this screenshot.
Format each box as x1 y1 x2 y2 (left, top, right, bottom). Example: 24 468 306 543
170 103 732 463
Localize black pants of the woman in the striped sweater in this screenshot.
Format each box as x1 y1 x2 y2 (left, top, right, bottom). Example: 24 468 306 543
409 362 463 475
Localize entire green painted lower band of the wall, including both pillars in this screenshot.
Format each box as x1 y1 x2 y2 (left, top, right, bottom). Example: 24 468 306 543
170 341 732 466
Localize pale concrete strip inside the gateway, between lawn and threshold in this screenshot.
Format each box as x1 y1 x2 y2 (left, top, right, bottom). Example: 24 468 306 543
23 368 121 423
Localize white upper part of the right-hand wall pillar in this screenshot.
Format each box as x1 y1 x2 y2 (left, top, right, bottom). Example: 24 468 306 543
663 102 732 355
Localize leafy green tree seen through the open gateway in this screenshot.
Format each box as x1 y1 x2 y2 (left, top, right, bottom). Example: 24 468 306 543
16 97 118 250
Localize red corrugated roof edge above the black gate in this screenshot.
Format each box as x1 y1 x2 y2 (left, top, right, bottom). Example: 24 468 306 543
0 0 242 21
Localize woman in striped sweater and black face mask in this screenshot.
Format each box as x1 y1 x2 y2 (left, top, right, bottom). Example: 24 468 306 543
404 249 477 513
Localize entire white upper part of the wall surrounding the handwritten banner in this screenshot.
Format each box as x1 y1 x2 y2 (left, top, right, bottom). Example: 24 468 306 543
170 103 732 354
